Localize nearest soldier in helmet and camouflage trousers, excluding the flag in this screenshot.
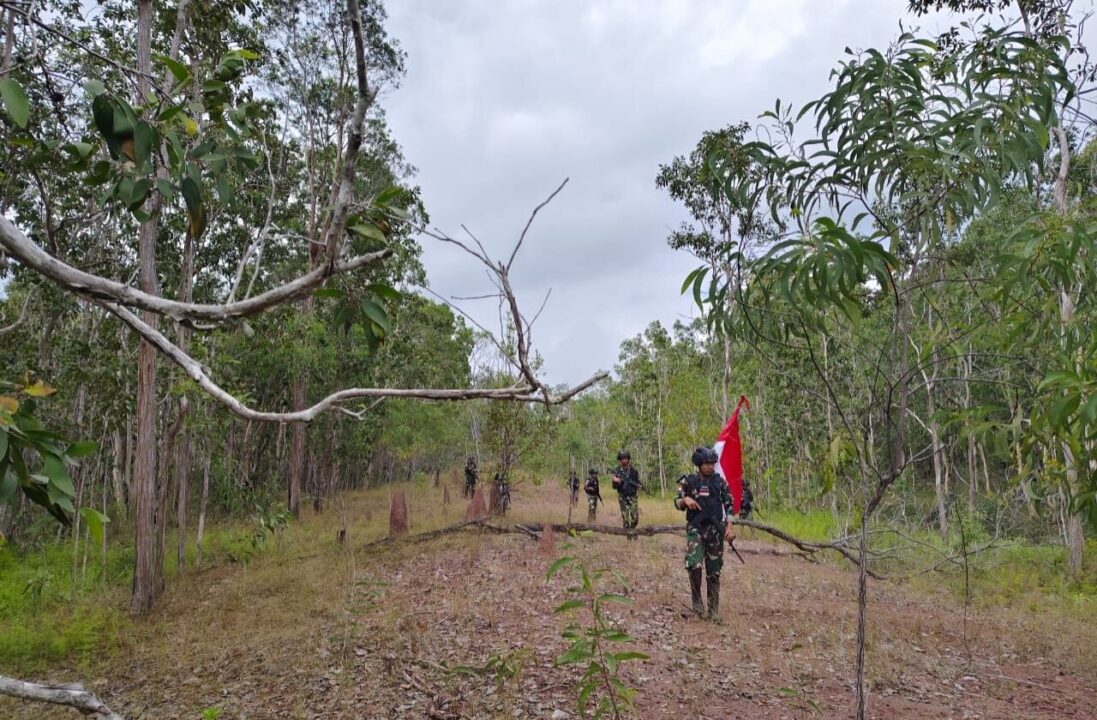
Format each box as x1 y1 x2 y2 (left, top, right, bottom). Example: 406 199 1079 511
675 448 735 622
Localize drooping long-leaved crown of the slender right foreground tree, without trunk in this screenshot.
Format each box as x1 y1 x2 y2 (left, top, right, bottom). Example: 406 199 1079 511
686 29 1072 337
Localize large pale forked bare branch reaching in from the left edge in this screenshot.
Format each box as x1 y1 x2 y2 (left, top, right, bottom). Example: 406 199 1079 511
0 0 608 432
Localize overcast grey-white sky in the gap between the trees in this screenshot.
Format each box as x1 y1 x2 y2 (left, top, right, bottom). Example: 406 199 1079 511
384 0 978 383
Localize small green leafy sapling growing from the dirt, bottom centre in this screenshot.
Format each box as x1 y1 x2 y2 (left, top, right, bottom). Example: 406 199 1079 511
546 556 647 720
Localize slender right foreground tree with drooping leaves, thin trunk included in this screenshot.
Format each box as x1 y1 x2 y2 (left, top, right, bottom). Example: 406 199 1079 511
688 22 1070 718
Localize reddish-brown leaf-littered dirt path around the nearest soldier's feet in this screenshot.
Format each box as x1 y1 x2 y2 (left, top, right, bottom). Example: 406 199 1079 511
316 538 1097 720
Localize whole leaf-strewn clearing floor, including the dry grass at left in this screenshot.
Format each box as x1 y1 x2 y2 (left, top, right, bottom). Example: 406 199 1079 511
0 487 1097 720
